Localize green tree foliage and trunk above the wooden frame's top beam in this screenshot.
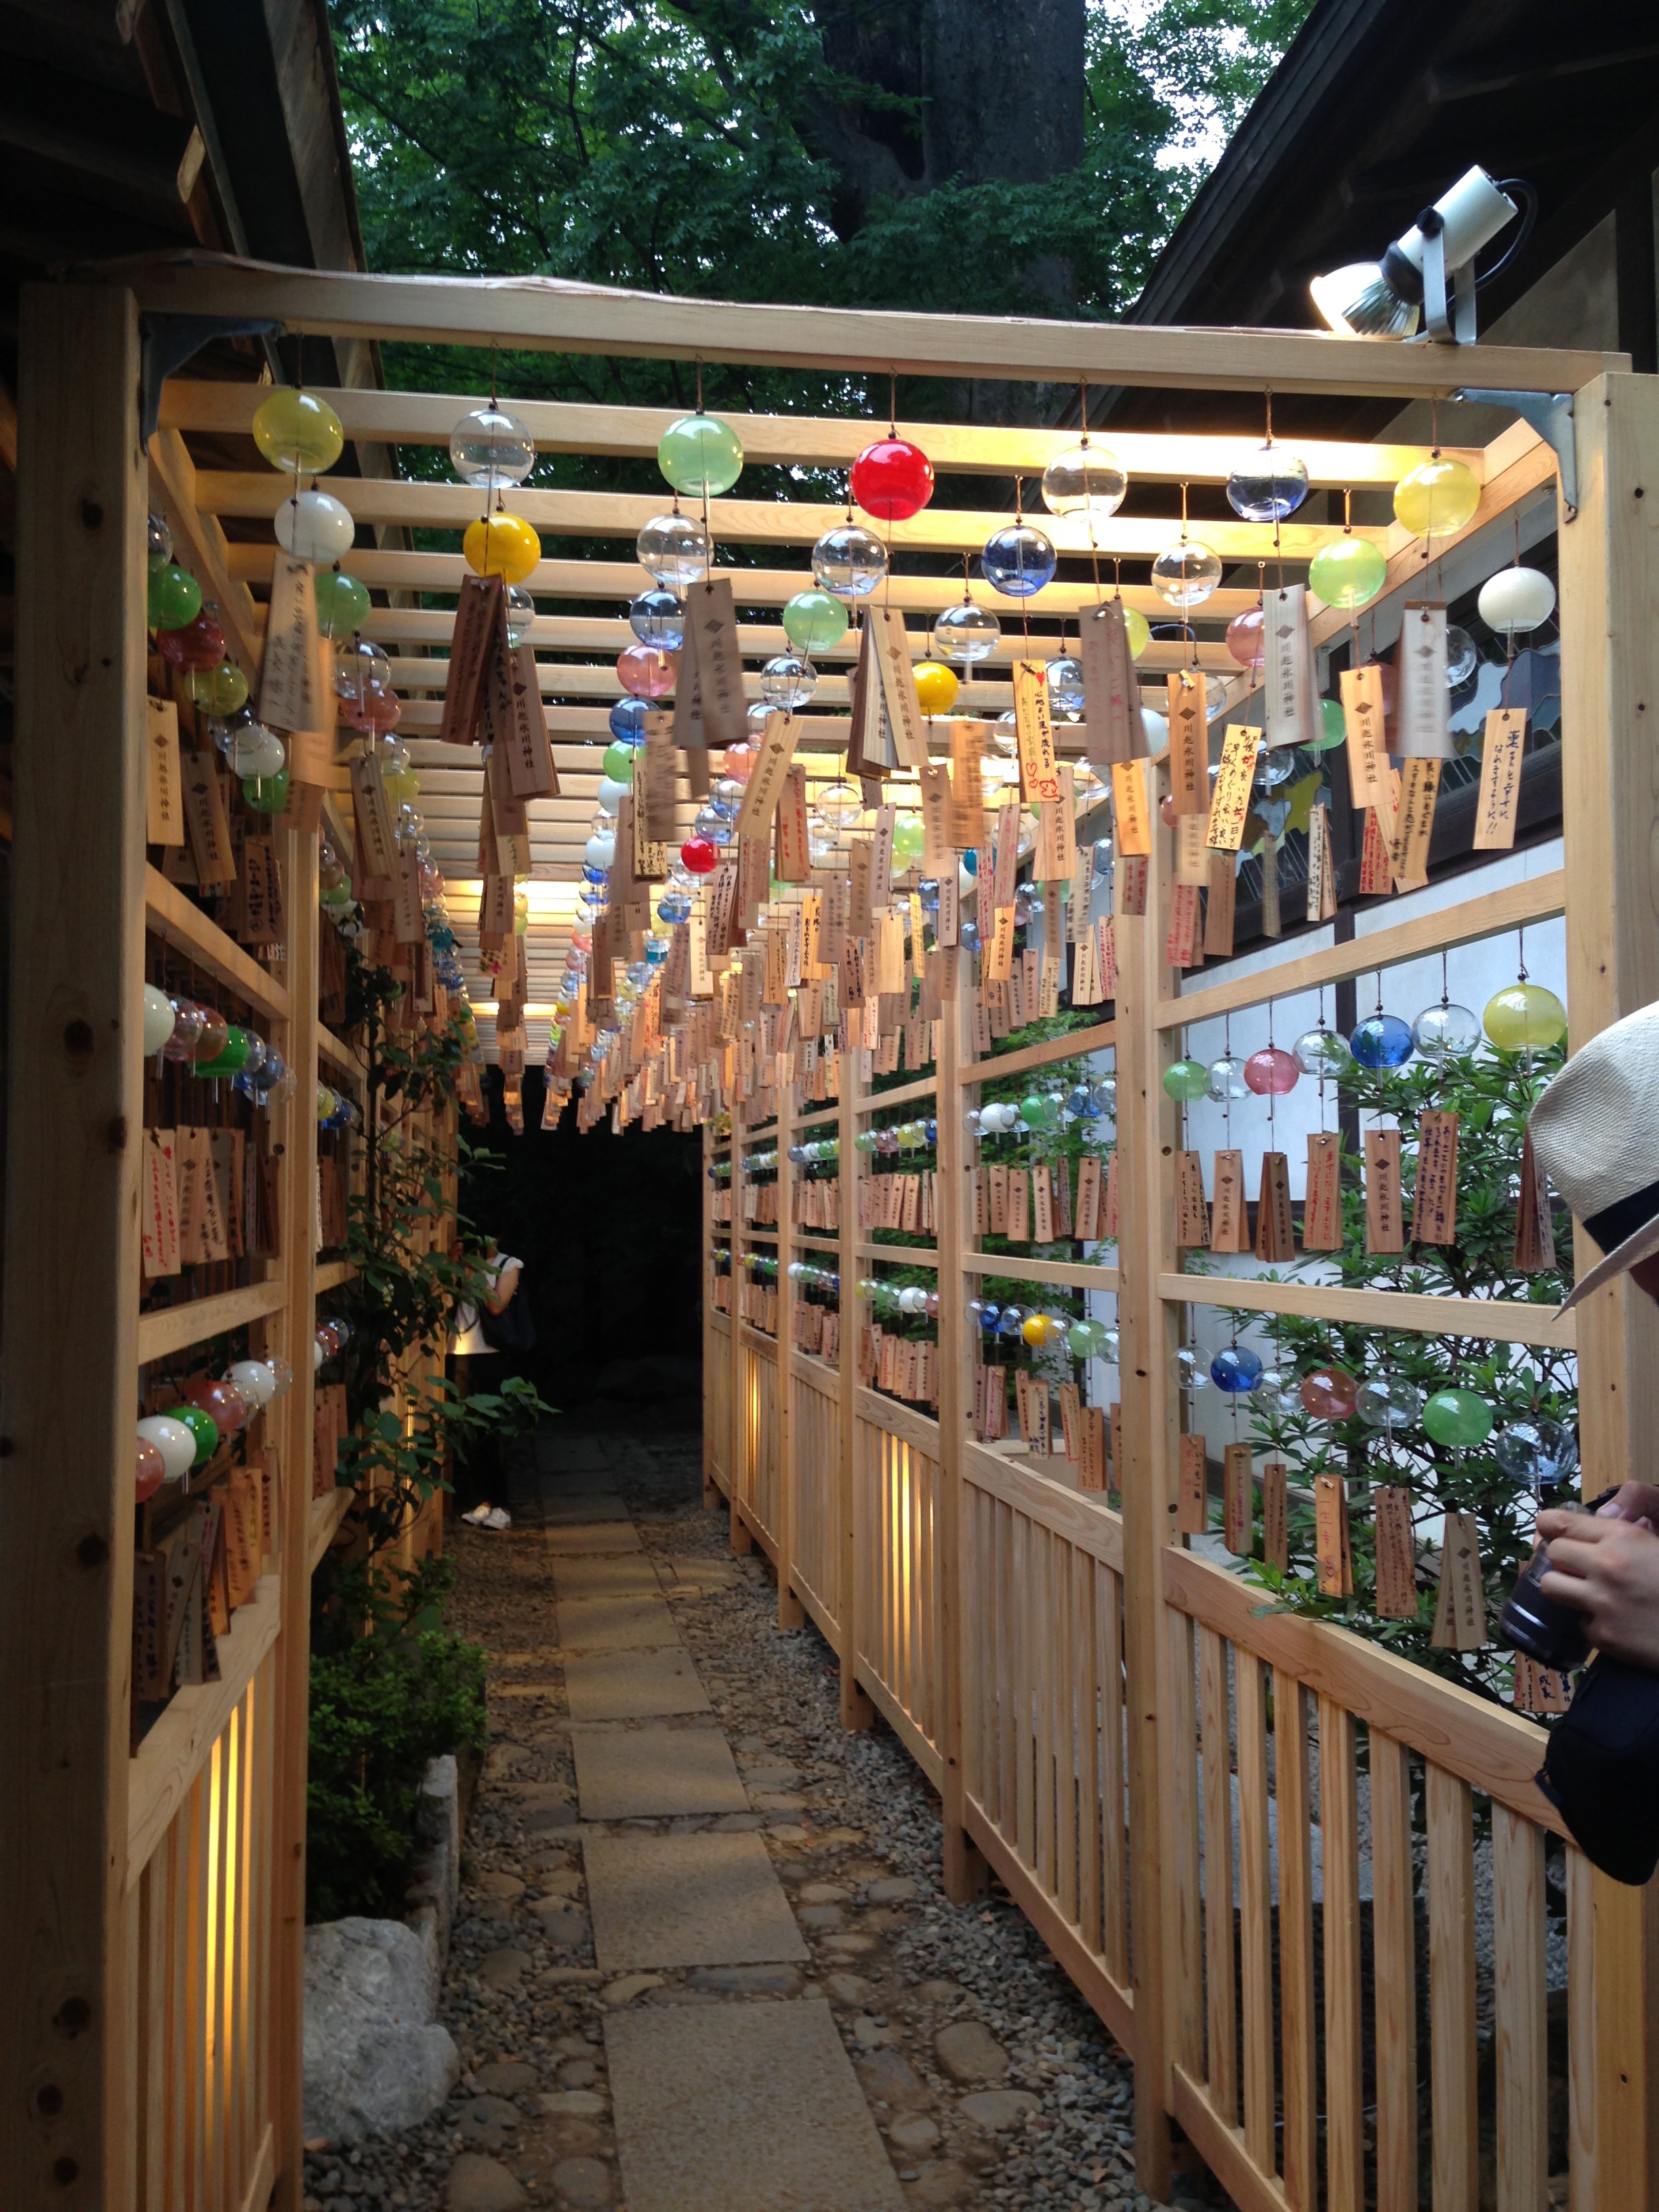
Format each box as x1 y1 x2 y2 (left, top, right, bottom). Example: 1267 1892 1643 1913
332 0 1309 409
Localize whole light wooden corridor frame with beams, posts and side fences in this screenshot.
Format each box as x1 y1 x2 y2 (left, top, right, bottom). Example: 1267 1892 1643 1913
0 254 1659 2212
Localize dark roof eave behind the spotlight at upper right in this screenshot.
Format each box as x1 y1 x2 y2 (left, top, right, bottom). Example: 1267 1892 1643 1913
1111 0 1659 429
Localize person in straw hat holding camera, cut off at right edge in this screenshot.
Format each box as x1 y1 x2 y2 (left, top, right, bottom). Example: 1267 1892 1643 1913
1528 1002 1659 1885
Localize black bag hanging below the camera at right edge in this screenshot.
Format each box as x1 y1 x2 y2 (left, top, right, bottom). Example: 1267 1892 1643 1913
1537 1659 1659 1887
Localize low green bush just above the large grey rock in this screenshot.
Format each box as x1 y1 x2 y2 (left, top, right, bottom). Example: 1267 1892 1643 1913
305 1628 487 1920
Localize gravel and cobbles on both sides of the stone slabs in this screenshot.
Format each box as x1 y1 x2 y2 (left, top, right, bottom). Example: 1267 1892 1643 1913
308 1433 1225 2212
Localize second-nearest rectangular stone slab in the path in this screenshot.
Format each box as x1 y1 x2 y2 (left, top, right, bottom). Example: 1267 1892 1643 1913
581 1829 810 1973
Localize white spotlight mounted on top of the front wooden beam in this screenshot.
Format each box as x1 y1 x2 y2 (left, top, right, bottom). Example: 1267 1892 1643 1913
1307 168 1537 345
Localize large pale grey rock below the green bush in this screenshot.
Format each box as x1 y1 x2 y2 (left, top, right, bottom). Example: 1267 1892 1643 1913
305 1918 460 2144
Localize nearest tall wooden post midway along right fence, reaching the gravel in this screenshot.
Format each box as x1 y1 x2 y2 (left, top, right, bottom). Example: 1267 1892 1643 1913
1117 838 1179 2198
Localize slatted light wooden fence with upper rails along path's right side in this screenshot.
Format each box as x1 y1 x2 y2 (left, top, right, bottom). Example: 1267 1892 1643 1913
710 367 1659 2212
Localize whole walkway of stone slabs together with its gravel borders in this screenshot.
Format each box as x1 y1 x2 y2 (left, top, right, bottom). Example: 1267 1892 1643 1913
308 1422 1225 2212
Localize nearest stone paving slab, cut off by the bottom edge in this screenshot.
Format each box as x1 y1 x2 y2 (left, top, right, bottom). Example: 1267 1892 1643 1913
604 1997 905 2212
